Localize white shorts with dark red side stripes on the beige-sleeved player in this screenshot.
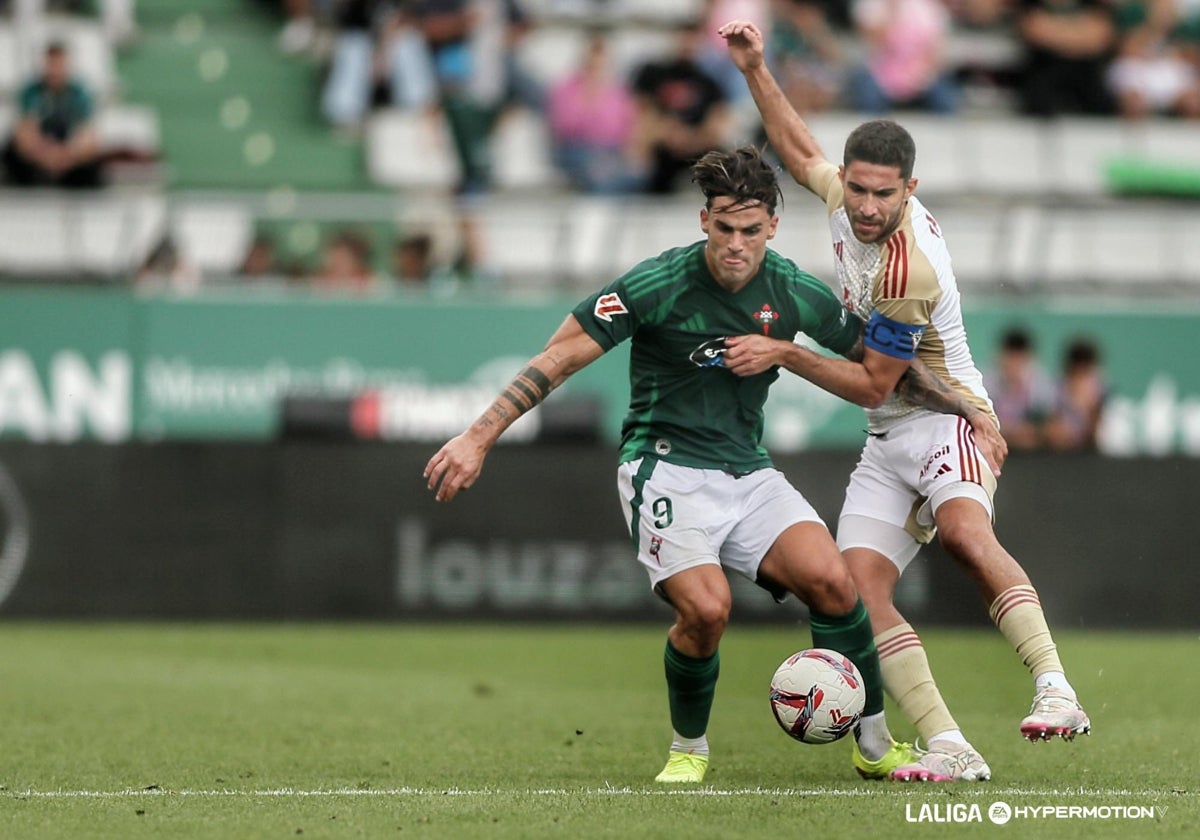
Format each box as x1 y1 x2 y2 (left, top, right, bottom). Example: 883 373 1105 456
838 414 996 571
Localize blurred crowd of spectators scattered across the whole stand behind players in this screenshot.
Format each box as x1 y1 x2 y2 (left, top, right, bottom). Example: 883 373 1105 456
0 0 1200 295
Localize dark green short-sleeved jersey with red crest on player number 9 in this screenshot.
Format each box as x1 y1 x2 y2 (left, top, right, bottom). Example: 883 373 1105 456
572 240 862 475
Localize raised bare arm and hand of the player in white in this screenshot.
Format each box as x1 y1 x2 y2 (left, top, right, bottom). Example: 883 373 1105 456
716 20 826 188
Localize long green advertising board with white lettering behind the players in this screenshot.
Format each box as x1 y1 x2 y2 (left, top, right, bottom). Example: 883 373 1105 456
0 289 1200 455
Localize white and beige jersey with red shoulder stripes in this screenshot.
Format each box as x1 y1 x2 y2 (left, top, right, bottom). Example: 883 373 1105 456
809 163 995 433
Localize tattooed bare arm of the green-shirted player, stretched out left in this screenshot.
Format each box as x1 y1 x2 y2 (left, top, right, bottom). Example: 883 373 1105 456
425 316 604 502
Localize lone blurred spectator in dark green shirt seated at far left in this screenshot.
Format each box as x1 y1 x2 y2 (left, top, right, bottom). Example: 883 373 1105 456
4 42 104 188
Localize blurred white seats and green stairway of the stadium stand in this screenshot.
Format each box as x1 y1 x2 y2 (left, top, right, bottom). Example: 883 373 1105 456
0 0 1200 294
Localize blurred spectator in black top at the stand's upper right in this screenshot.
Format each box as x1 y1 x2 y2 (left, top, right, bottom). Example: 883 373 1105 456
1016 0 1116 116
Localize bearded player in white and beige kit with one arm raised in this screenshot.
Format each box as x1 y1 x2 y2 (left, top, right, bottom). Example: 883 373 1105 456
720 20 1091 781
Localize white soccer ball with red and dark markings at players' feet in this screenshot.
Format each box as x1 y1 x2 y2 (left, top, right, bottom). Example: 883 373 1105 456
770 648 866 744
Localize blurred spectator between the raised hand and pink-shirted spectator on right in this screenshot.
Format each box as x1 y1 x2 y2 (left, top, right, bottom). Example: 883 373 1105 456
768 0 845 114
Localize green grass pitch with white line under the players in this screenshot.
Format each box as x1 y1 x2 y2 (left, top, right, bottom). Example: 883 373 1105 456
0 623 1200 840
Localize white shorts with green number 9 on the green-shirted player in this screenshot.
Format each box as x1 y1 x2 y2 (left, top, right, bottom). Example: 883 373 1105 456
617 458 824 595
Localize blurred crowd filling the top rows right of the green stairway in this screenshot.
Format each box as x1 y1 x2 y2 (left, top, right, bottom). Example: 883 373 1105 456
267 0 1200 199
